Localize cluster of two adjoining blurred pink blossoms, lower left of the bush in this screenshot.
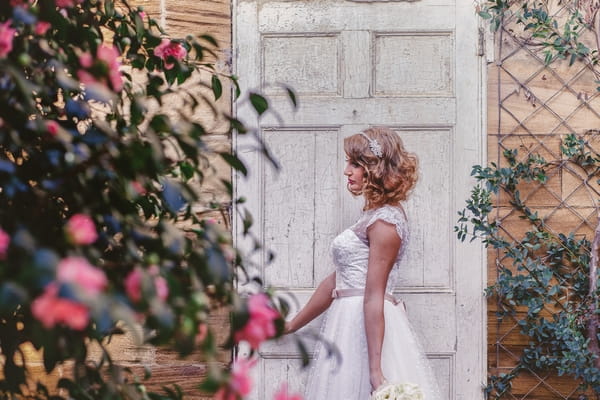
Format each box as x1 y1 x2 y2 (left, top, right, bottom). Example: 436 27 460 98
31 257 108 330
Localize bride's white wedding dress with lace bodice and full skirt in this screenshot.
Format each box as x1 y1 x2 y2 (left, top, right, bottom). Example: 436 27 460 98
305 205 442 400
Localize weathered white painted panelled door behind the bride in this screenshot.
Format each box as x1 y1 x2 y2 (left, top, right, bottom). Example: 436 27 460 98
234 0 485 400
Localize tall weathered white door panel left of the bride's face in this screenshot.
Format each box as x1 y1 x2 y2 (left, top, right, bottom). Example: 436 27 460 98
263 129 340 288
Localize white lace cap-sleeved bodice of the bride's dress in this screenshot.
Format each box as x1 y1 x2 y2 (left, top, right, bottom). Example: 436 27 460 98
331 205 409 293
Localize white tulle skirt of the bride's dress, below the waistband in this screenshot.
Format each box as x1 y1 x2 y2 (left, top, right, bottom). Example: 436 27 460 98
305 296 443 400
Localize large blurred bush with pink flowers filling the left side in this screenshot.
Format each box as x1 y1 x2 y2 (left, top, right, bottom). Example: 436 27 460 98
0 0 294 399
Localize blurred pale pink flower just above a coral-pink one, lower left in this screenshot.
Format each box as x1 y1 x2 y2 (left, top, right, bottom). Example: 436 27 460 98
56 257 108 295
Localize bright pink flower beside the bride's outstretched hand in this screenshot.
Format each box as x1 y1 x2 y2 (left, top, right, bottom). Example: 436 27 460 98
234 293 279 349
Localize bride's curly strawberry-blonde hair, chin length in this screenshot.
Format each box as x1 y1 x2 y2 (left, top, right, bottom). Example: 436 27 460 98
344 126 418 210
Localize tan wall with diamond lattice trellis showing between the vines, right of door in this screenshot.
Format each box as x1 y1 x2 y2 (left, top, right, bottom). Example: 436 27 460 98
488 1 600 400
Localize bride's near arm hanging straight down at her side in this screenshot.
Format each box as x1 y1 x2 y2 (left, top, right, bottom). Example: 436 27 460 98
363 220 401 389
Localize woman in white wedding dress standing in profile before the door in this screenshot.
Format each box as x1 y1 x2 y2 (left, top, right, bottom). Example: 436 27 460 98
286 127 442 400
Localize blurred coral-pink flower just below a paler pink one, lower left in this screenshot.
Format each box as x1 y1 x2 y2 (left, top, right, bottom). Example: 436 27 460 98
31 283 89 331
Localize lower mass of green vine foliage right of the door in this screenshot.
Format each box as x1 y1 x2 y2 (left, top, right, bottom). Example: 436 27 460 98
455 134 600 398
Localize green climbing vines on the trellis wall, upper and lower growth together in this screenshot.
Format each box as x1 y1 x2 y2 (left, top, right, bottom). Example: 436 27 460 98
468 0 600 399
